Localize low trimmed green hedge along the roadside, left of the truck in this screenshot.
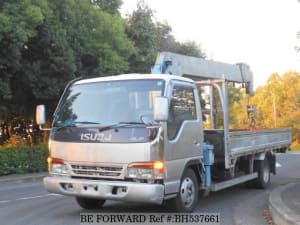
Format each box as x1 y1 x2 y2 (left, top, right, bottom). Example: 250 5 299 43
0 145 48 176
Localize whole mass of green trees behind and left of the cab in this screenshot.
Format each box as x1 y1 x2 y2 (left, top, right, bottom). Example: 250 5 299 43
0 0 204 120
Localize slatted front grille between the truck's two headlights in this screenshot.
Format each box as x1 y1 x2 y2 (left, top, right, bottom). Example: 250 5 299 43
71 165 123 178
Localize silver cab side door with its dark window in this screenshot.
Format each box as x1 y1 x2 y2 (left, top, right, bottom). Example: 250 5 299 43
165 81 203 194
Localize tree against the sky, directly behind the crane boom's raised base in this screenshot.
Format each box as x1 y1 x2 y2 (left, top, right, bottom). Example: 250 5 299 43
126 1 205 73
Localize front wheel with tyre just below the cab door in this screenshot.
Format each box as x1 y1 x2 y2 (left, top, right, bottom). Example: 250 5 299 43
167 169 199 212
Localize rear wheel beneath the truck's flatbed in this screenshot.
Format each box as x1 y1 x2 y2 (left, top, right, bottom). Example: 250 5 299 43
254 157 271 189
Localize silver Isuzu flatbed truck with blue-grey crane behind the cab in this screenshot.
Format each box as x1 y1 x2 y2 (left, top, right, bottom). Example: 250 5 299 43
36 52 291 212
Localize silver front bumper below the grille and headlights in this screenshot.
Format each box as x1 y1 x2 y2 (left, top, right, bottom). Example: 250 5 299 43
44 177 164 204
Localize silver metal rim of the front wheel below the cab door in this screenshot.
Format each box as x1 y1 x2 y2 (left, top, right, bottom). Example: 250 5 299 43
180 177 195 208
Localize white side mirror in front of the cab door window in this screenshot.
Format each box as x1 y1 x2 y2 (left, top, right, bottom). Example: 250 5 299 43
153 96 169 121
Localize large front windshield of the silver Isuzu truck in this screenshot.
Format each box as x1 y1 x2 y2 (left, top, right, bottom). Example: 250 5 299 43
53 79 164 127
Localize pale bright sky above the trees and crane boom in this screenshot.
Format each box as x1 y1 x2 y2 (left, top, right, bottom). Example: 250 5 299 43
121 0 300 88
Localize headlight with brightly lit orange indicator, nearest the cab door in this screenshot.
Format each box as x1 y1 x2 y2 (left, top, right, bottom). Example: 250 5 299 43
126 161 164 180
